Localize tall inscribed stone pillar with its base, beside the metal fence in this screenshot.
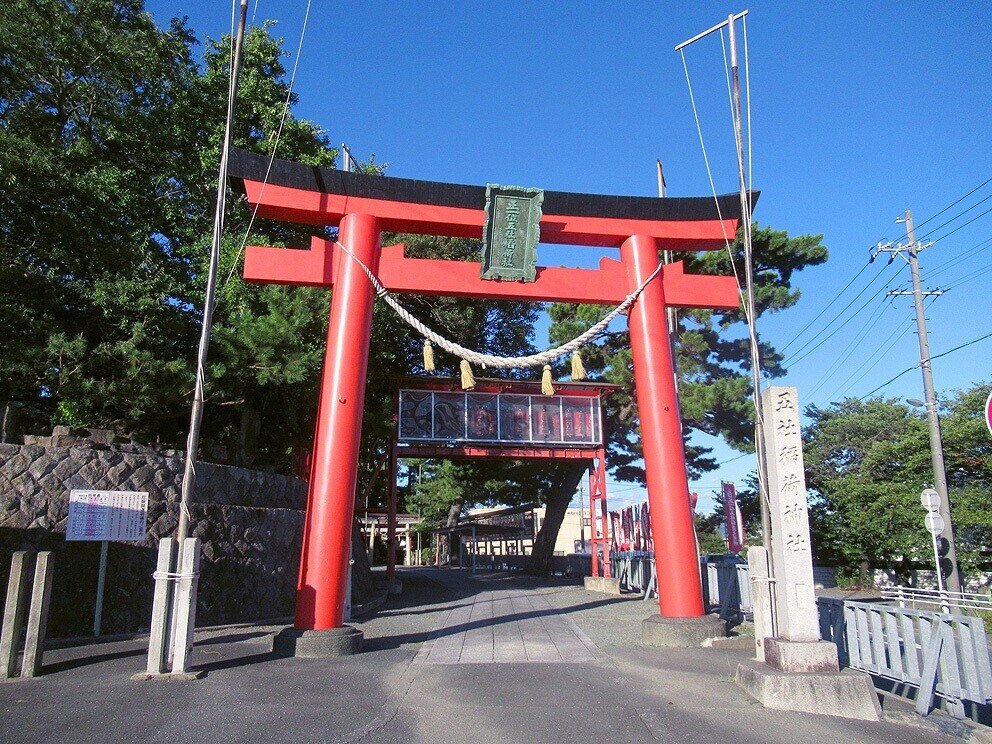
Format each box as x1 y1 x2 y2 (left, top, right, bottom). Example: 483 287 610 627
737 387 881 721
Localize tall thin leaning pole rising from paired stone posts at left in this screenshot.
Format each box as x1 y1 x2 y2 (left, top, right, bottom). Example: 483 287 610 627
176 0 248 548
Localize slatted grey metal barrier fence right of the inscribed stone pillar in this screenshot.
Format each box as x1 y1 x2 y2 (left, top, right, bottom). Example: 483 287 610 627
817 597 992 718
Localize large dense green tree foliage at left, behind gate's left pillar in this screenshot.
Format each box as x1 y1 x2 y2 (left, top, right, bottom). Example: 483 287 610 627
0 0 536 482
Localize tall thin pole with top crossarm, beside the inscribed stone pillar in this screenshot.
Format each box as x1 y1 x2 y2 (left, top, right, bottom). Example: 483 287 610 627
727 14 775 560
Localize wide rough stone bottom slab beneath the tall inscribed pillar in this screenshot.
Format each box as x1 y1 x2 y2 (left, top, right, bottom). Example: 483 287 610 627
735 660 882 721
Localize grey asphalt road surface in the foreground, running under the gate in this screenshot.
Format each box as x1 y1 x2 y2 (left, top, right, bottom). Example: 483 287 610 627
0 569 960 744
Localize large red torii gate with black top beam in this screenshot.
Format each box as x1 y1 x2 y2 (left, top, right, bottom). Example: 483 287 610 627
230 150 740 644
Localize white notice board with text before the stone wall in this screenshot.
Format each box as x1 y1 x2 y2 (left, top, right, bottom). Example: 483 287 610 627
65 491 148 542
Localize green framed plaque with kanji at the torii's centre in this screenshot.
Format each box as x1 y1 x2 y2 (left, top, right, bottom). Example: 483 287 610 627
482 184 544 282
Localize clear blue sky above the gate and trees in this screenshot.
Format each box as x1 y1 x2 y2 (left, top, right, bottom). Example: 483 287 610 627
149 0 992 509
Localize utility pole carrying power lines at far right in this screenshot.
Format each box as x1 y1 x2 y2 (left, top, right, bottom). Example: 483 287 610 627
905 209 961 592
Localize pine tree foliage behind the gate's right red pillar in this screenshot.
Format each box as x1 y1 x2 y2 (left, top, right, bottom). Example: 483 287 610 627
550 225 827 483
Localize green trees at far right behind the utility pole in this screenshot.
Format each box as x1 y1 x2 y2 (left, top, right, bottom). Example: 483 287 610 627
803 384 992 572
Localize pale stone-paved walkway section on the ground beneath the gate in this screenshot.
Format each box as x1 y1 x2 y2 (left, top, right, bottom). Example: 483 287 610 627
414 589 601 664
